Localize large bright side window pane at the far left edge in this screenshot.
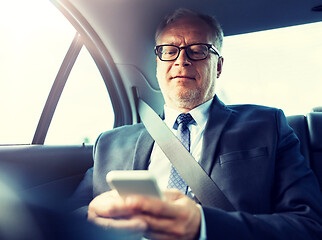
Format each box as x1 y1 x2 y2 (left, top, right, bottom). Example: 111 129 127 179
0 0 75 144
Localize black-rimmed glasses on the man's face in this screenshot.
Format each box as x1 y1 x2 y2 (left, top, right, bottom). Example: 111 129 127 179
154 43 220 61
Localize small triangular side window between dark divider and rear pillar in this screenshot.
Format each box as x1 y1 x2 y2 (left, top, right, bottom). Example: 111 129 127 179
45 47 114 145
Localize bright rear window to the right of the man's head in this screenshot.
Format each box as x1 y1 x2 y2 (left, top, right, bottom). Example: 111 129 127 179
217 22 322 115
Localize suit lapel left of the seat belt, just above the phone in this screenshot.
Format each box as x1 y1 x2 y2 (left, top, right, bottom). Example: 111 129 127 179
133 128 154 170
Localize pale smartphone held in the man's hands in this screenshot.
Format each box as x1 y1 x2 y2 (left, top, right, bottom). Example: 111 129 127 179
106 170 164 199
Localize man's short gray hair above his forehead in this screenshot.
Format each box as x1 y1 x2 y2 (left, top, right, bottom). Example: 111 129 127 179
155 8 224 51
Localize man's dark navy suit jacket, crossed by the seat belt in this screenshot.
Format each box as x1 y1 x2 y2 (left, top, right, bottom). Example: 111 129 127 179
71 97 322 240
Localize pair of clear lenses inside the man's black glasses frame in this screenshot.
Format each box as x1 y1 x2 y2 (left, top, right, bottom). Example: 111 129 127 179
158 44 209 61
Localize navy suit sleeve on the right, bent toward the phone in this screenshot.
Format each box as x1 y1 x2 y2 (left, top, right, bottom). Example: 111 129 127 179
203 111 322 240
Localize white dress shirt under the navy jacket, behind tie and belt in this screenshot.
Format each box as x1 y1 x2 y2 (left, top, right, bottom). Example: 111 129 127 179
148 99 212 240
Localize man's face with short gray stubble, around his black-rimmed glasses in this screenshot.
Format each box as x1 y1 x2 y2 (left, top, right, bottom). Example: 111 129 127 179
157 18 223 112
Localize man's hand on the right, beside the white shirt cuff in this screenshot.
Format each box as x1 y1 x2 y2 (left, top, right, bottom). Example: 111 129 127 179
129 190 201 240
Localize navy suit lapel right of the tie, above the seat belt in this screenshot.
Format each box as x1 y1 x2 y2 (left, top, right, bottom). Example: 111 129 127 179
200 96 232 175
